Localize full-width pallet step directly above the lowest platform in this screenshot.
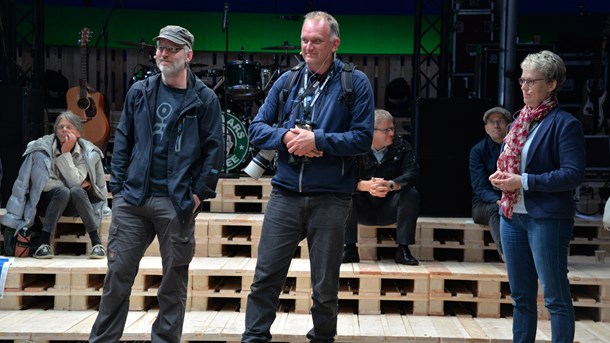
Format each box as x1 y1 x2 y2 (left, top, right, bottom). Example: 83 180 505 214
0 256 610 321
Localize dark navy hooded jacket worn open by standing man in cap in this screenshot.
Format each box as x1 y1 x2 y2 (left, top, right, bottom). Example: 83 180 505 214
110 70 224 222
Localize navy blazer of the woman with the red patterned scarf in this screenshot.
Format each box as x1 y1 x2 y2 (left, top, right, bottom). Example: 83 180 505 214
522 107 585 219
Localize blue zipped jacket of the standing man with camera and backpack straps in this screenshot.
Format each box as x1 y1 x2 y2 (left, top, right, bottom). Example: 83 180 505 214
248 59 375 194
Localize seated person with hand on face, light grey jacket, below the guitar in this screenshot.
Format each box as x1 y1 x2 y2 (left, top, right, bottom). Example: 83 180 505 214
2 111 108 258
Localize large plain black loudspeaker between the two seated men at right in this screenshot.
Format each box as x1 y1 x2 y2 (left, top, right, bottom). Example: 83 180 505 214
414 98 492 217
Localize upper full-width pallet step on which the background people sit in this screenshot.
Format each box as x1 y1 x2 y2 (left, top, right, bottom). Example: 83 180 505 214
0 210 610 262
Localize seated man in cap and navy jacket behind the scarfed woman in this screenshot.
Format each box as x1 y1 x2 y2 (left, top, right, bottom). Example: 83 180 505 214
469 107 513 259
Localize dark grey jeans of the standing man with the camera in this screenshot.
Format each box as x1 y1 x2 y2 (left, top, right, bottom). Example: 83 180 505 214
242 188 350 342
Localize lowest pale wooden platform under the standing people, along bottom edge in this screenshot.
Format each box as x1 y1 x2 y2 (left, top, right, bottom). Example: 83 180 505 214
0 310 610 343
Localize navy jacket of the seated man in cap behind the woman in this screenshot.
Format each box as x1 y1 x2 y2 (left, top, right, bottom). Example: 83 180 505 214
468 136 502 204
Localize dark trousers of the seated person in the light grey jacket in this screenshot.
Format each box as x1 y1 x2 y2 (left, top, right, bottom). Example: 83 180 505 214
37 186 98 235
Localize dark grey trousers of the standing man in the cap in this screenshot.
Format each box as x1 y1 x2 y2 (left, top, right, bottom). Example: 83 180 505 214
89 196 196 343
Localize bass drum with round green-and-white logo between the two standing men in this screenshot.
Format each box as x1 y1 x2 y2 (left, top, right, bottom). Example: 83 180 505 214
222 111 251 172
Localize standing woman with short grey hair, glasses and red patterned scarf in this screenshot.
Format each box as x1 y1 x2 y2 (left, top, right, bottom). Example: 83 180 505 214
489 50 585 343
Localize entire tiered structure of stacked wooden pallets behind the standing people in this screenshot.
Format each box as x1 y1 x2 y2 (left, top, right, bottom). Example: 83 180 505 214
0 178 610 342
